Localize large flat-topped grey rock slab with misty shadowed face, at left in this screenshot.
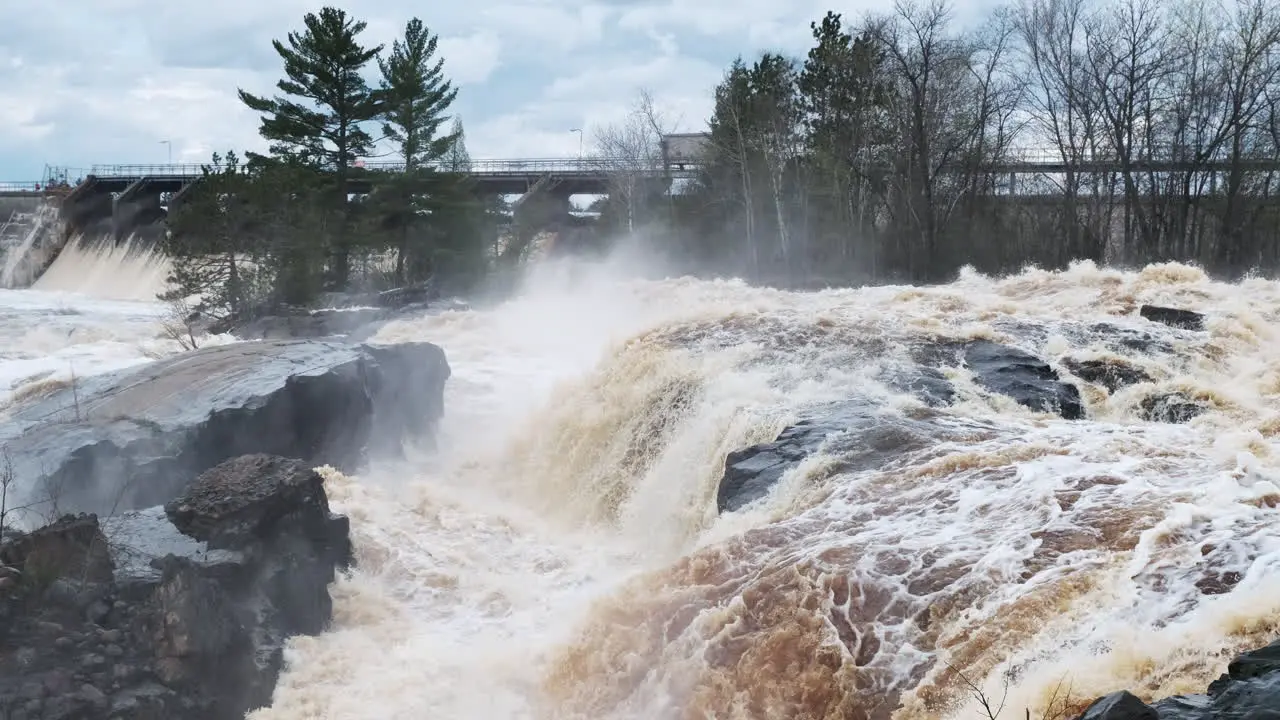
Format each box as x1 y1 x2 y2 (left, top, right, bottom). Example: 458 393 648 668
0 341 449 514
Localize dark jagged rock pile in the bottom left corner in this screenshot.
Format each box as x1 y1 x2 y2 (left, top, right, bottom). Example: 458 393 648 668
0 455 351 720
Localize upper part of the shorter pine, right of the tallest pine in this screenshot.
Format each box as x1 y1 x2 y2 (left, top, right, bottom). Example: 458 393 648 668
378 18 458 173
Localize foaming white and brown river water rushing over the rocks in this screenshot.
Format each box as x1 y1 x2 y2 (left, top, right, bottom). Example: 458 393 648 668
0 238 1280 720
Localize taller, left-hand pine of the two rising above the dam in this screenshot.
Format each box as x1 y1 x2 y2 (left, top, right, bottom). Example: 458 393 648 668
239 6 383 288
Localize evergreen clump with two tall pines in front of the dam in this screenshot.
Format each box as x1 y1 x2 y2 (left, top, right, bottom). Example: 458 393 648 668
164 8 502 318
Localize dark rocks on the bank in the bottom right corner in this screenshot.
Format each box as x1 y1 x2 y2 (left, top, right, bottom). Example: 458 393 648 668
1080 641 1280 720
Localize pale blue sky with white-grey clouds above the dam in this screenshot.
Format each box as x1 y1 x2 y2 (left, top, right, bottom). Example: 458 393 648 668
0 0 988 181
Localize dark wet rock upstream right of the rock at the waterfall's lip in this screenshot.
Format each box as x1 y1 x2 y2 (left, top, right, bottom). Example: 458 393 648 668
964 341 1084 420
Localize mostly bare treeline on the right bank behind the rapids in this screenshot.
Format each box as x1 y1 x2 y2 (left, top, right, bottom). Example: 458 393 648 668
599 0 1280 286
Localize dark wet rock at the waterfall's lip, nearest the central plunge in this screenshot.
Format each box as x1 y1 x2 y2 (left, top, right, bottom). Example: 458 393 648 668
716 402 931 512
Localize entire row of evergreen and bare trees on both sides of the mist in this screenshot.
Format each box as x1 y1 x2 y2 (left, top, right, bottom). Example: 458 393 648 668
166 0 1280 315
